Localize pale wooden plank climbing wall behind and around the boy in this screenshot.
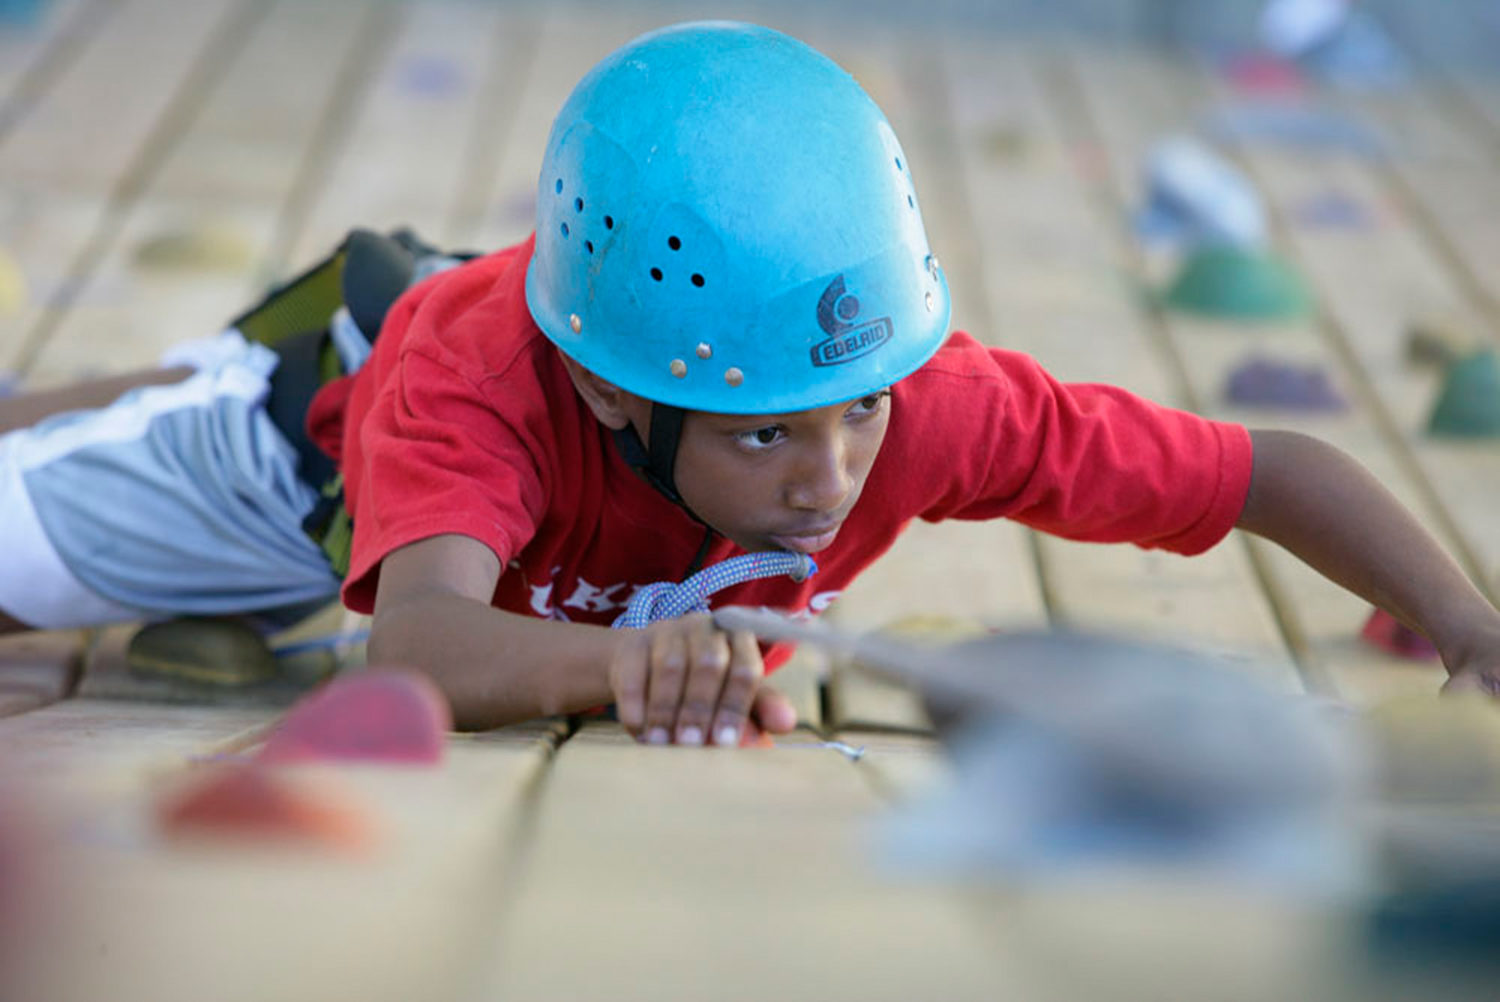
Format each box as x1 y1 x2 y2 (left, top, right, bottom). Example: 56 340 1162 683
0 0 1500 1002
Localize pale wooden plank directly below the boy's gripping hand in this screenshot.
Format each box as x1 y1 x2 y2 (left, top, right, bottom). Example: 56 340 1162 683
479 726 1029 999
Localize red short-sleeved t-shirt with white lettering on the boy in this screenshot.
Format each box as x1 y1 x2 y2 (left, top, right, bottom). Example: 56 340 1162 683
309 240 1251 668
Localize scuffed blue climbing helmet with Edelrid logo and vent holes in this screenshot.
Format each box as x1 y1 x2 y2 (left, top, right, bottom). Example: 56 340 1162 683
527 21 950 417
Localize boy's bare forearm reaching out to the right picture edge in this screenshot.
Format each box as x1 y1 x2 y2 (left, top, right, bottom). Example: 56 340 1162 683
1238 431 1500 696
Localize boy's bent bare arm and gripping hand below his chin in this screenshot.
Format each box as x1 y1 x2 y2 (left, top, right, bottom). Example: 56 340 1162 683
369 536 797 744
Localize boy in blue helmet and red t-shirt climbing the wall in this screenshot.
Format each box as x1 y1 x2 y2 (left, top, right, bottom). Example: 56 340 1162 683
0 23 1500 744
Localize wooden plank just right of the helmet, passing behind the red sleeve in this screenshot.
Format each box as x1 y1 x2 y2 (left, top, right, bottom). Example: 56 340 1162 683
944 45 1301 689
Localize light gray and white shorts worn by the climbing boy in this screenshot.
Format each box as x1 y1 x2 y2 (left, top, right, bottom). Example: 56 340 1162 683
0 332 339 629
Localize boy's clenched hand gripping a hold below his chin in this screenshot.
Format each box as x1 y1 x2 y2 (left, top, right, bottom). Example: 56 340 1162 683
609 614 797 747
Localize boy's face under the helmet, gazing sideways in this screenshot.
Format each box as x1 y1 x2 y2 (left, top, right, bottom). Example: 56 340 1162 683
669 390 891 554
